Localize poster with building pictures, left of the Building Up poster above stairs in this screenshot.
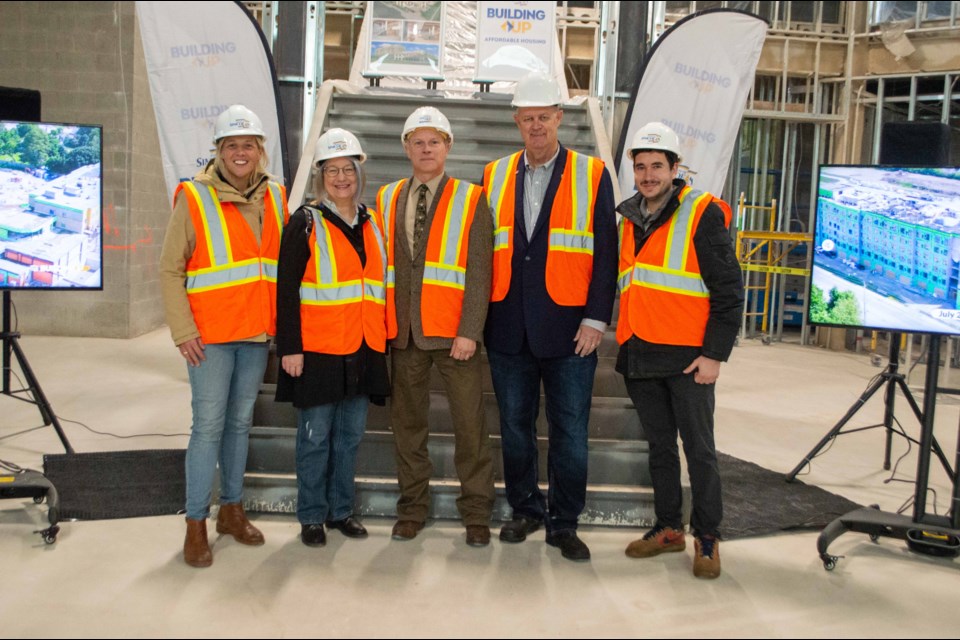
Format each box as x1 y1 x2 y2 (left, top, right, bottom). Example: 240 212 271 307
367 2 444 77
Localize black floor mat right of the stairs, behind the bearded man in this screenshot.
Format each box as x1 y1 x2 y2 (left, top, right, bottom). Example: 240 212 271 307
717 452 861 540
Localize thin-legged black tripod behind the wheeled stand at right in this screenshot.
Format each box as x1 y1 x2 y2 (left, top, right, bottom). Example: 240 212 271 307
786 333 953 482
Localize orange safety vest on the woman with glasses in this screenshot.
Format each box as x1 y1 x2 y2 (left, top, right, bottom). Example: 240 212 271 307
300 207 387 356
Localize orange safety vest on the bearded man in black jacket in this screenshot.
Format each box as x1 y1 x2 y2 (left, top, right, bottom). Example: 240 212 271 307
617 186 732 347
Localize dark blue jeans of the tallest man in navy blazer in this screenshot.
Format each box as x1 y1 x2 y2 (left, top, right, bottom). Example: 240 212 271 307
487 349 597 533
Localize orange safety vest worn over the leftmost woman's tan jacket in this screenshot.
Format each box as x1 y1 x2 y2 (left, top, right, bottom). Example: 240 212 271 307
173 181 288 344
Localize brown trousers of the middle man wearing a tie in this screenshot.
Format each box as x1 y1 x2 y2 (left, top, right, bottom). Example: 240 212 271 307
390 341 494 525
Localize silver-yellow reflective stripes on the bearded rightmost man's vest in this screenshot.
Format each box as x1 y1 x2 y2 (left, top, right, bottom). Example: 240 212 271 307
632 189 713 298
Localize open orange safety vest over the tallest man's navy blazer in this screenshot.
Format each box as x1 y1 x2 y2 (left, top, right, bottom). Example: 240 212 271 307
483 149 604 307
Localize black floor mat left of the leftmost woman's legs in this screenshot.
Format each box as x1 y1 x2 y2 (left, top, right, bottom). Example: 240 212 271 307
43 449 186 520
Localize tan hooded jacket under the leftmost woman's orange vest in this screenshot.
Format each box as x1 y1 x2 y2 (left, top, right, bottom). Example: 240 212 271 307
160 163 276 345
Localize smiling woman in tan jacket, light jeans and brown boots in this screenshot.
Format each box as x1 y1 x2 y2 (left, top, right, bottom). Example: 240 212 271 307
160 105 287 567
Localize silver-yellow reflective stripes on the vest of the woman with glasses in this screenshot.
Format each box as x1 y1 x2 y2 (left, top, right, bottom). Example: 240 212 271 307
300 207 387 305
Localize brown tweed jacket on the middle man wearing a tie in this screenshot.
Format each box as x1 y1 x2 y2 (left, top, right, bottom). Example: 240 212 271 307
390 174 493 349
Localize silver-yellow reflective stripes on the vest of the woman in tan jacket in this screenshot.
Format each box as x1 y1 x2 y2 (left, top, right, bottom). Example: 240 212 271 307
182 182 283 293
